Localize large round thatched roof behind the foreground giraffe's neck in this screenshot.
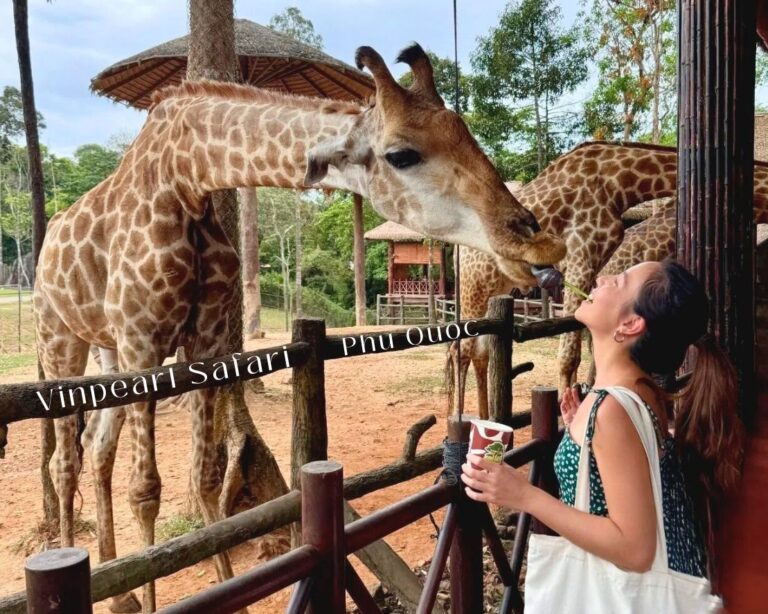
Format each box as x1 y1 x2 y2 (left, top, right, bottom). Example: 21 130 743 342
91 19 375 109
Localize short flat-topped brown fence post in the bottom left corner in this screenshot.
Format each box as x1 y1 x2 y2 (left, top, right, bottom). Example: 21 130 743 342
24 548 93 614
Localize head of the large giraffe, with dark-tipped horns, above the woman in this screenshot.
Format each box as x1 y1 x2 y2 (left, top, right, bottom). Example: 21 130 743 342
305 44 565 280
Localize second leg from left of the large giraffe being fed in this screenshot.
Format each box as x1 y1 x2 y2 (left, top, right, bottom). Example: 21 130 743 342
83 348 141 613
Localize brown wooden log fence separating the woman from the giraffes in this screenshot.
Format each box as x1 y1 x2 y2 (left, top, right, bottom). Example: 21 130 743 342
0 297 581 614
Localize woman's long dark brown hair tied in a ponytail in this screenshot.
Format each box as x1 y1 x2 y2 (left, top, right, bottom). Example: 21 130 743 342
630 259 744 556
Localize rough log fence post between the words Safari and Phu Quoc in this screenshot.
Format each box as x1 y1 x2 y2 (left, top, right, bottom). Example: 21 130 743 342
291 318 328 548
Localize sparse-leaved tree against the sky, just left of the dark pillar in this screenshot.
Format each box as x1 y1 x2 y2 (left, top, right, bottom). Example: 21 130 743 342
584 0 676 143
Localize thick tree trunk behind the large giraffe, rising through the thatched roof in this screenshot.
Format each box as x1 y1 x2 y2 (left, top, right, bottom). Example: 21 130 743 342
187 0 288 514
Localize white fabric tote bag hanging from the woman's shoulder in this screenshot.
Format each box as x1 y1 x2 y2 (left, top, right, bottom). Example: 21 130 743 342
525 387 722 614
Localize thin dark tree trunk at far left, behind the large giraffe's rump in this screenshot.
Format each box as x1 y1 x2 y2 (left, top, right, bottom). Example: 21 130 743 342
13 0 59 527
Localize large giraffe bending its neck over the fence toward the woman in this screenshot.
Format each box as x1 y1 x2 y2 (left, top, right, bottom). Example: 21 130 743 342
34 45 565 612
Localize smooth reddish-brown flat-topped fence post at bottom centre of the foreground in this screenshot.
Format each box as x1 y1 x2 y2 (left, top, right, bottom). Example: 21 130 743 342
301 461 346 614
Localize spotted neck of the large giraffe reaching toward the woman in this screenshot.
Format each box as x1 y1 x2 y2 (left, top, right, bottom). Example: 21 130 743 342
150 83 367 200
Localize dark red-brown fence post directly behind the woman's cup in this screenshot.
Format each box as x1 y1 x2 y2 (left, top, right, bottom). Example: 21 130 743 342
448 414 483 614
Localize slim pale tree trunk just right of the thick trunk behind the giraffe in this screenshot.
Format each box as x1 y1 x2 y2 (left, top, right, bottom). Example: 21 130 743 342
238 188 263 339
